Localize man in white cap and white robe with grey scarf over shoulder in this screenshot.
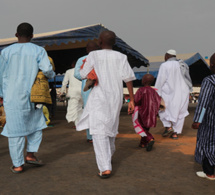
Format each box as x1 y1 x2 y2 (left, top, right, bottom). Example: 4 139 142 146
155 49 192 139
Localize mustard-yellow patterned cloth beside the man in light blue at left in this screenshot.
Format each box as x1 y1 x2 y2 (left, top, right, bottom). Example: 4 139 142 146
31 71 52 104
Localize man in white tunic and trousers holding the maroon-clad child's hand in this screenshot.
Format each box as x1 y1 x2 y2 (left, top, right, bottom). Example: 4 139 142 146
76 31 136 178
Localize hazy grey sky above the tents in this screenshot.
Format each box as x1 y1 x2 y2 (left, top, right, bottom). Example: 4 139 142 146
0 0 215 56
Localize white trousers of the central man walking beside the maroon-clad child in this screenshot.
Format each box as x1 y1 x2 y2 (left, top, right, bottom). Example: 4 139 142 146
92 135 115 172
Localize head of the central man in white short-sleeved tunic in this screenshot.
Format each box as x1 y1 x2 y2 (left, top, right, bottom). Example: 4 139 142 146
99 30 116 49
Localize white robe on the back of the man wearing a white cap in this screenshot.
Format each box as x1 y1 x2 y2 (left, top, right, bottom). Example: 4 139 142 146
155 60 189 121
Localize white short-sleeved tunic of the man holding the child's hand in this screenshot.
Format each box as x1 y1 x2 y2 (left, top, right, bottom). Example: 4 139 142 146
77 49 135 137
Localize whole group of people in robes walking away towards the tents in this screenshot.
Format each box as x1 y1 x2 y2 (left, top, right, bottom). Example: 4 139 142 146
0 23 215 180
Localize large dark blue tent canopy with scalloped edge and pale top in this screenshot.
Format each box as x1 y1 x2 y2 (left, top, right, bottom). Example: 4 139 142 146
0 24 148 73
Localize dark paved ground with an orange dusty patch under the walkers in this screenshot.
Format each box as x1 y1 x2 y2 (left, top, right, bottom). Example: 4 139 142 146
0 105 215 195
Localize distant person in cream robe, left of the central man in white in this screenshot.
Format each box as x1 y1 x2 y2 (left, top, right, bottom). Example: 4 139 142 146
60 62 83 125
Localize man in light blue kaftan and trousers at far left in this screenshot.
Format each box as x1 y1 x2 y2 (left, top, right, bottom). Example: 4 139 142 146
0 23 55 173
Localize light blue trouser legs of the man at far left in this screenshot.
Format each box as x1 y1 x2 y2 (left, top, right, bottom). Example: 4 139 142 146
8 131 42 167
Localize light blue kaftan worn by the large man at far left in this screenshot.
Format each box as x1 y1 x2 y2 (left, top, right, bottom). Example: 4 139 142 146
0 43 55 137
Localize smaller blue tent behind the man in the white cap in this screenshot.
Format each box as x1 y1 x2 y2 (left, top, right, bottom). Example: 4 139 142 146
133 53 211 86
